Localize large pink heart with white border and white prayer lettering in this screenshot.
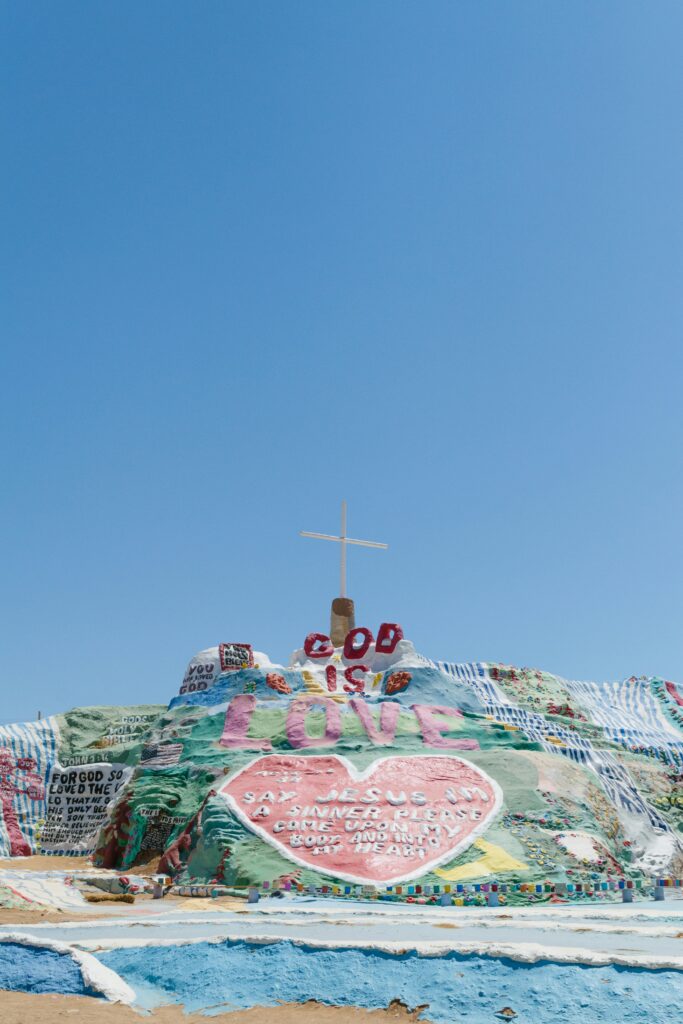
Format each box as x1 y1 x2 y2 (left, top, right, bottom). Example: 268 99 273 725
220 754 503 885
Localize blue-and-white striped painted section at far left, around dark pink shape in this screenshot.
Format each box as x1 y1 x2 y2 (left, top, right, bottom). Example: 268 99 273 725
0 716 59 857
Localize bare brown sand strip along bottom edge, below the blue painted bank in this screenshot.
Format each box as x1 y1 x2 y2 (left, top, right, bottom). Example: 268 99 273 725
0 991 428 1024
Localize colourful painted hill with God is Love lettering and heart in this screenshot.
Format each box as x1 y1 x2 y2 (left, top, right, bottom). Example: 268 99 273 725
0 626 683 887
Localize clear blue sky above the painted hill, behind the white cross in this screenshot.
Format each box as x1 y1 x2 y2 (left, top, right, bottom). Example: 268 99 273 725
0 0 683 721
